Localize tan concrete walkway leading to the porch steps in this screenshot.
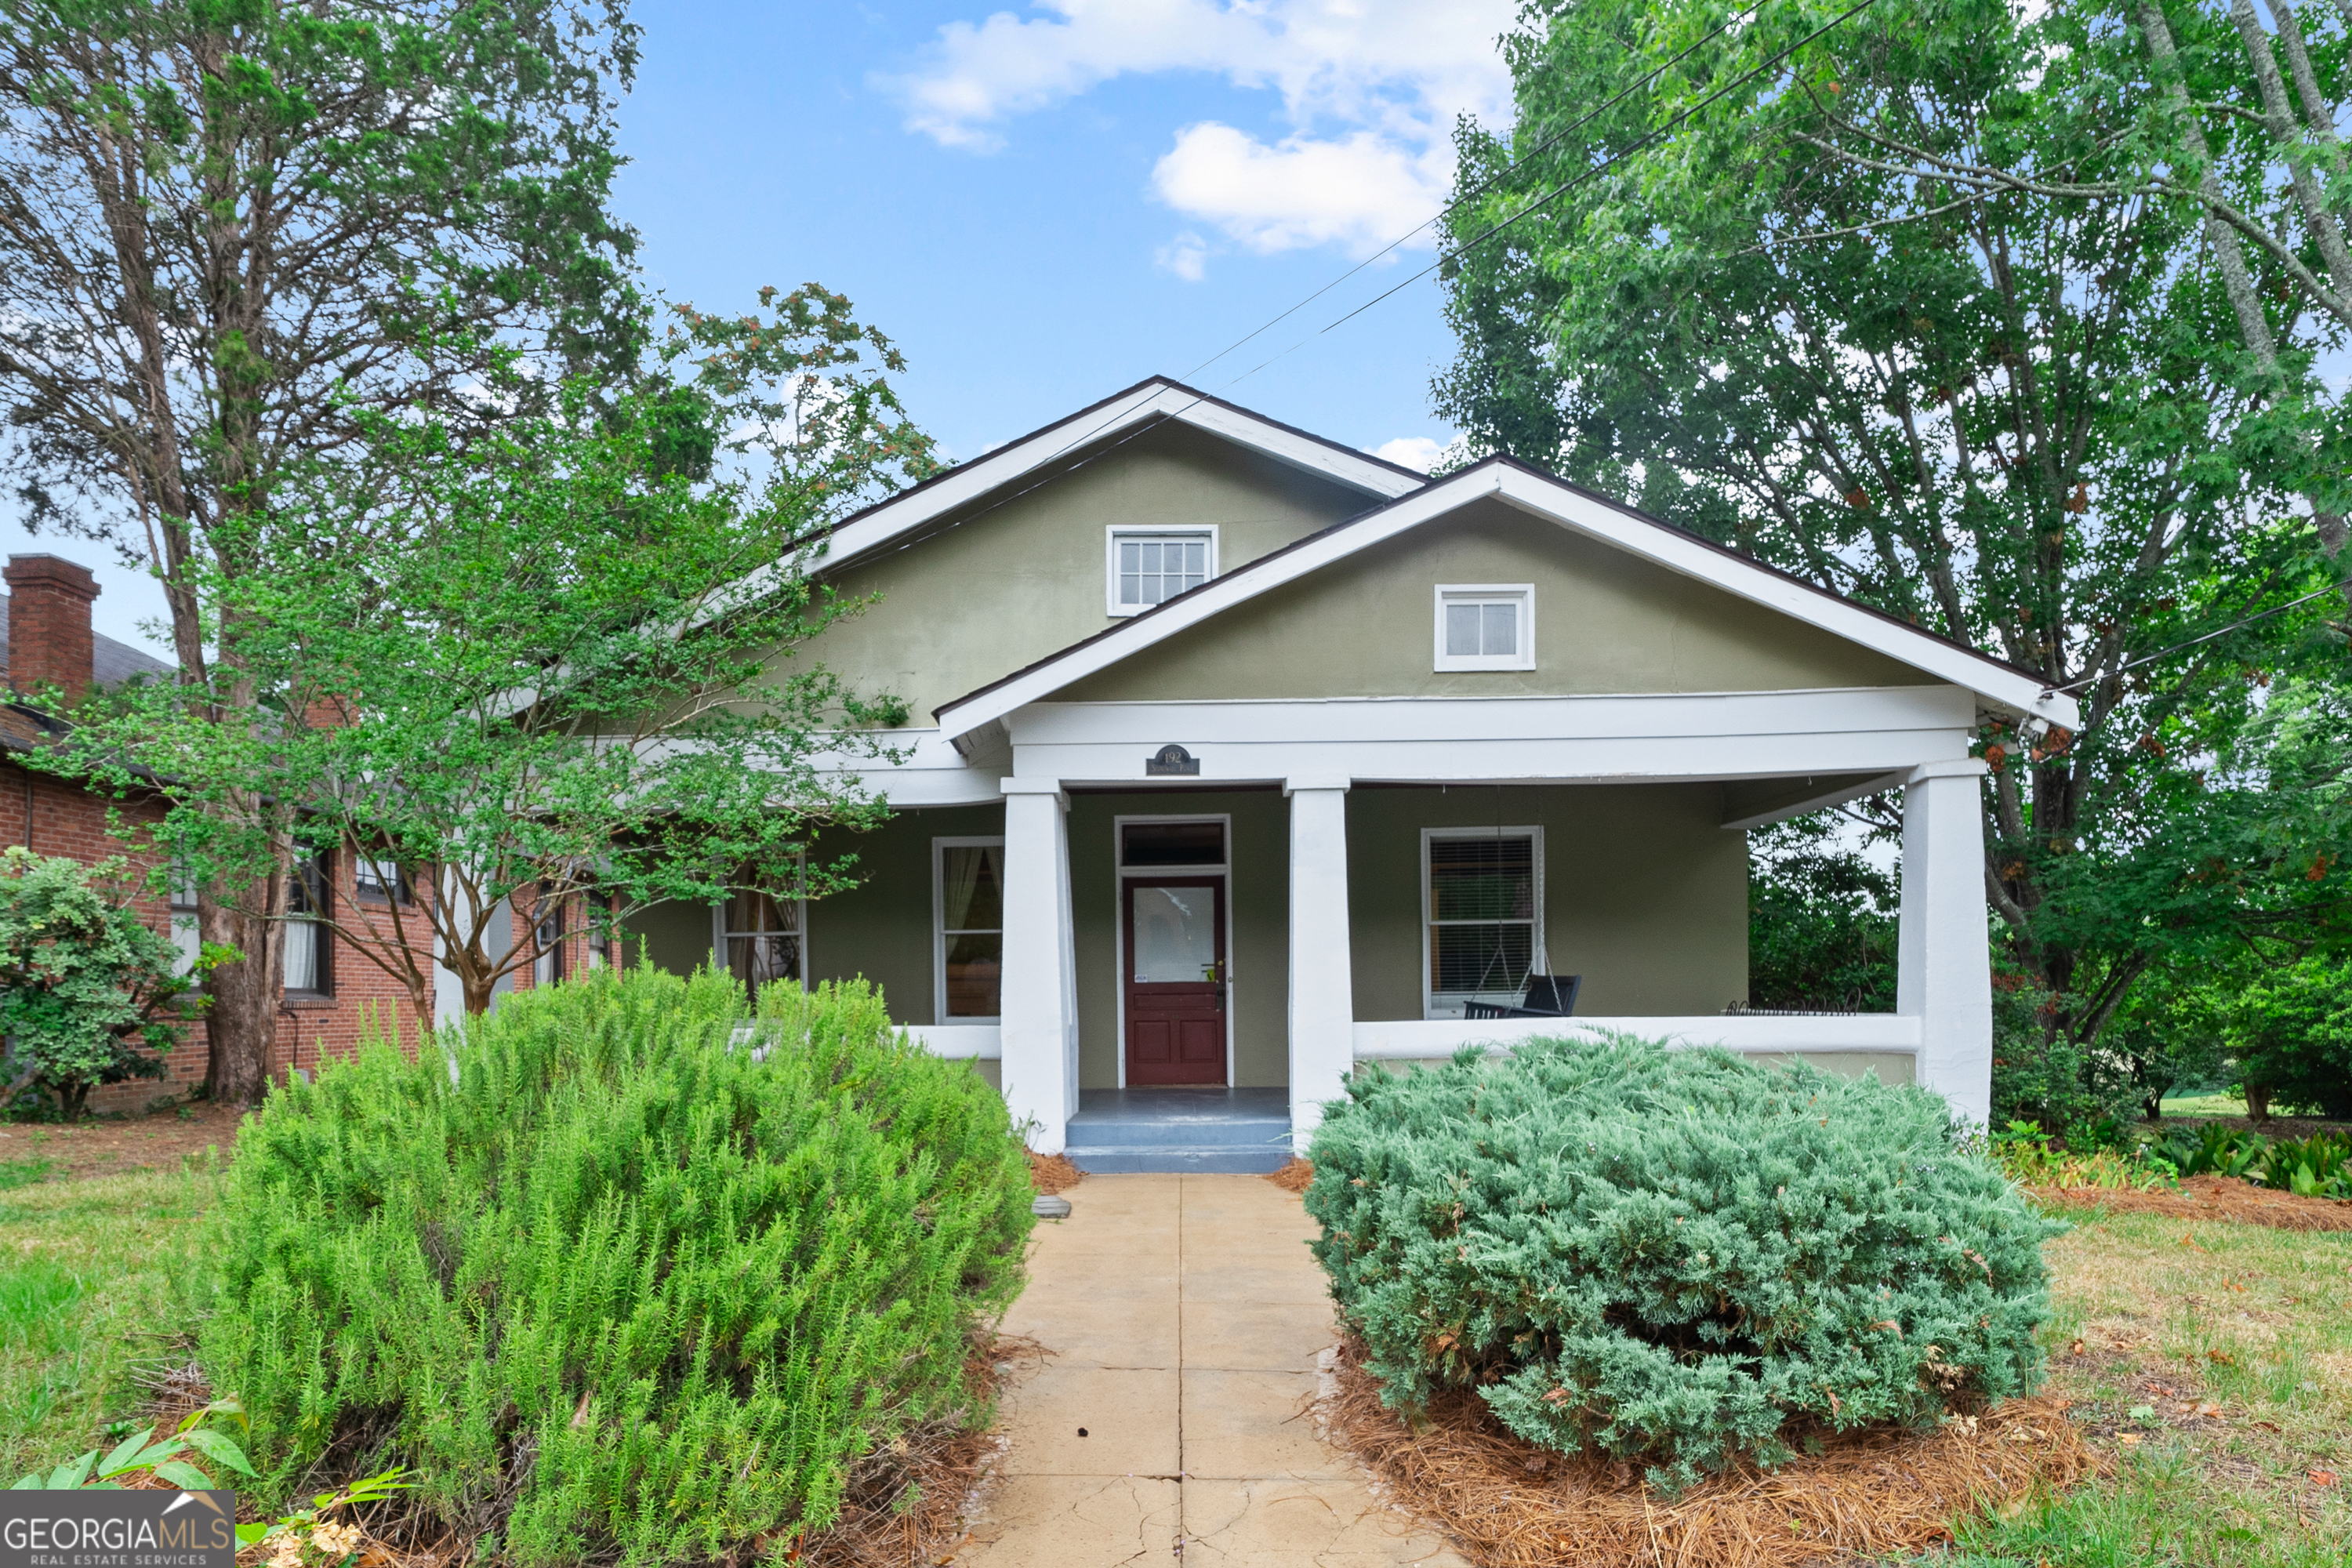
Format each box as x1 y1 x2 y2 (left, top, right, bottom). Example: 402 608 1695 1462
955 1175 1465 1568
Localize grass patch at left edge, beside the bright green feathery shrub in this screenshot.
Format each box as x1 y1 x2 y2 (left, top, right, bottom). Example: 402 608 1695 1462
0 1161 212 1486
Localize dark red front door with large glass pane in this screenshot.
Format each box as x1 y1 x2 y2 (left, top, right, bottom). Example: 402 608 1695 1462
1120 877 1225 1086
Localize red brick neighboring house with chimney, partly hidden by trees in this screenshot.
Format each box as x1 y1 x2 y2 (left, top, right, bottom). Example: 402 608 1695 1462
0 555 602 1112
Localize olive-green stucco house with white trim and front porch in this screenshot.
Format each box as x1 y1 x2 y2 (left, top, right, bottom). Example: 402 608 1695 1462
621 379 2077 1152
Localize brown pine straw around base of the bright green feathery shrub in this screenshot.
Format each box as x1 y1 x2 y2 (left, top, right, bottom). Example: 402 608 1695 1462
122 1335 1049 1568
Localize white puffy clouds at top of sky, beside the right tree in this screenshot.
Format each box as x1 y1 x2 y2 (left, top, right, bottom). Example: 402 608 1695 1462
877 0 1515 256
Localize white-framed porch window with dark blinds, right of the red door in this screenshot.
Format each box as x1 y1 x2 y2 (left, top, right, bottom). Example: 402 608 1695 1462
1421 827 1543 1018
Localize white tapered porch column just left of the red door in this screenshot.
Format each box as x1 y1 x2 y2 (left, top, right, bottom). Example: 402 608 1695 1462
1000 779 1077 1154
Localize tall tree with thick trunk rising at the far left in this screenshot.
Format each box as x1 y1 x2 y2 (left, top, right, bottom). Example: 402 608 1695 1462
0 0 642 1100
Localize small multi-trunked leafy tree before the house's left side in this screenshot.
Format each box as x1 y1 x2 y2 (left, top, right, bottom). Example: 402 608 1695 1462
32 285 934 1018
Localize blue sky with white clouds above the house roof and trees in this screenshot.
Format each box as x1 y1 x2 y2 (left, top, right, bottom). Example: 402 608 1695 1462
0 0 1512 658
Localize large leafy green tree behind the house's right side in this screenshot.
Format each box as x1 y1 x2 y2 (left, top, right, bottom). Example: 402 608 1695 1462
1437 0 2352 1067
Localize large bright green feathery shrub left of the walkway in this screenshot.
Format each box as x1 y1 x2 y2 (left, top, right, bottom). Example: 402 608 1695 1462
200 968 1033 1563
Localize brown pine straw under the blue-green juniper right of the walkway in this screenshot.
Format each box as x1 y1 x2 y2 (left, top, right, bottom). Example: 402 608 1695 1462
1319 1342 2105 1568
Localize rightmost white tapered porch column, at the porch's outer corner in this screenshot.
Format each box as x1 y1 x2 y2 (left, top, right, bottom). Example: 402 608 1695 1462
1896 757 1992 1126
